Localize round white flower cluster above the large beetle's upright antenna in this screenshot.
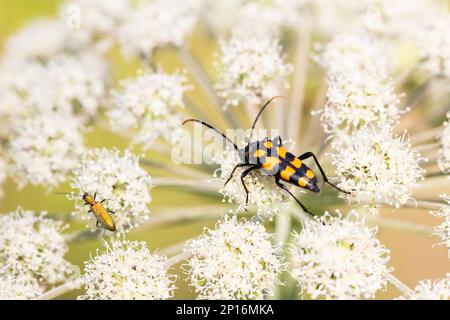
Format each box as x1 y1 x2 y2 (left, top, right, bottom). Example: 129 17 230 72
215 34 292 107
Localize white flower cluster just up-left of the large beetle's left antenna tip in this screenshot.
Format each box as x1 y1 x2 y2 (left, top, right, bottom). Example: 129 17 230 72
107 72 190 149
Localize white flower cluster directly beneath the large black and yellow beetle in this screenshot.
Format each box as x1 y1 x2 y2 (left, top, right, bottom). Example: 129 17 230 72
214 150 288 220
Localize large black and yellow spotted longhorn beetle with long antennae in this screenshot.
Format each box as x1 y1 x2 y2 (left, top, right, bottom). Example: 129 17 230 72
183 96 349 216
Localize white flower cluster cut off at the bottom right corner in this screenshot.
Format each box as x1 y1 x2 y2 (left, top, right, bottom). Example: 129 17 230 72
399 273 450 300
